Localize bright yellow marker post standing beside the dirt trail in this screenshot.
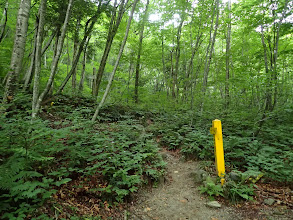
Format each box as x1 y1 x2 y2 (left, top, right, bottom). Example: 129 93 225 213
210 119 225 185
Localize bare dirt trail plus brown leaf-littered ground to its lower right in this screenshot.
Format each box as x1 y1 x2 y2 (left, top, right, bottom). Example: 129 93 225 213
124 150 293 220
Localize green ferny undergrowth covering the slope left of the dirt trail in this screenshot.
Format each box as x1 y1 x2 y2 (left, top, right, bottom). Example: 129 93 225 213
0 98 165 219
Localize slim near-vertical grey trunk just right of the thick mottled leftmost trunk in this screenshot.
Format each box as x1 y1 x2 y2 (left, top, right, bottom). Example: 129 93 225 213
32 0 47 118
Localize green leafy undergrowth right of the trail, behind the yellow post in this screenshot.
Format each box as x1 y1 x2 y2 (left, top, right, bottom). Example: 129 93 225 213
150 106 293 185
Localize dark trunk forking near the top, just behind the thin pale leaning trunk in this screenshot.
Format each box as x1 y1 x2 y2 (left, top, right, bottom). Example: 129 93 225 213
93 0 128 97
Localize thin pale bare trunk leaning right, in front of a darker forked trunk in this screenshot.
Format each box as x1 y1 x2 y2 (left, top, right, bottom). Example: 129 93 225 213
92 0 139 121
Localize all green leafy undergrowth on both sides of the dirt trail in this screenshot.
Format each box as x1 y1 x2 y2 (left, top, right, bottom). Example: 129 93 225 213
0 95 293 219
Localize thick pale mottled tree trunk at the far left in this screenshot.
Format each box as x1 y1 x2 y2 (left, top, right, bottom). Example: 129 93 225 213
3 0 31 103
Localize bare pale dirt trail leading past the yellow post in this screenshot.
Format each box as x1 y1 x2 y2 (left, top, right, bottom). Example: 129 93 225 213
127 152 241 220
